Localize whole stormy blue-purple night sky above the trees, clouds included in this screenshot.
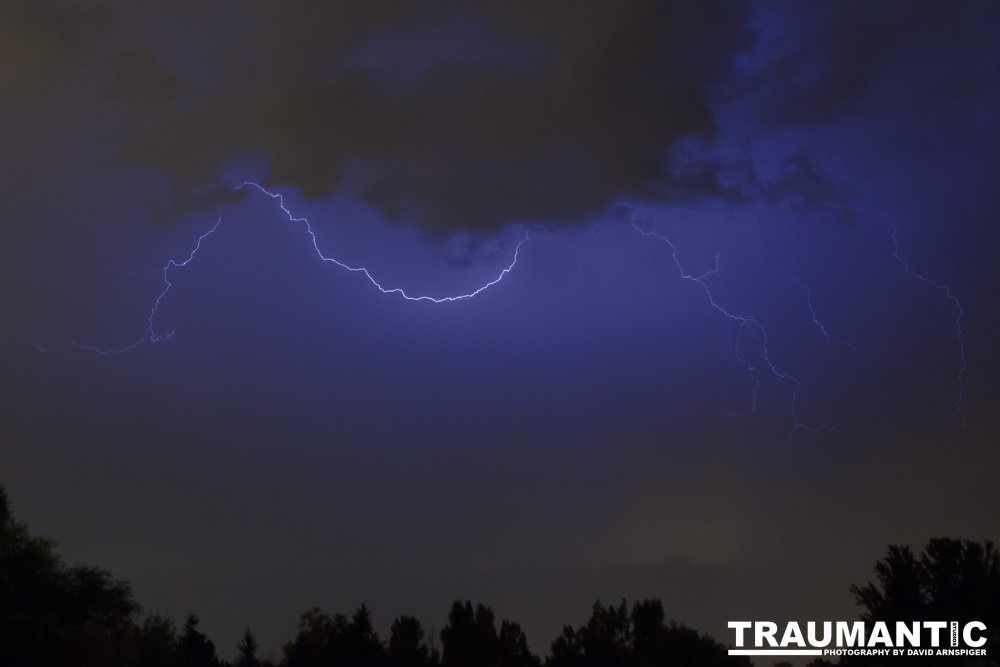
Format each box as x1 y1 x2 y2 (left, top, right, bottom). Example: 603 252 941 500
0 0 1000 656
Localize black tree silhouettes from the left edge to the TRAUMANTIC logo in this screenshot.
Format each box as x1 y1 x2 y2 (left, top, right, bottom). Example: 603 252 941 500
0 486 749 667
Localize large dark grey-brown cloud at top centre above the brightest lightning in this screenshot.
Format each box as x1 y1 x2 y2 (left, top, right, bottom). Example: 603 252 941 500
122 0 746 233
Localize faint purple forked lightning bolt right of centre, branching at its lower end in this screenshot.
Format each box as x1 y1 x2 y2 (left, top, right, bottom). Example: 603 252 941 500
632 216 833 438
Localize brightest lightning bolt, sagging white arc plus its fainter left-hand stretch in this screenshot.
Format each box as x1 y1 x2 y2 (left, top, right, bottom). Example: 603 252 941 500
62 181 529 355
